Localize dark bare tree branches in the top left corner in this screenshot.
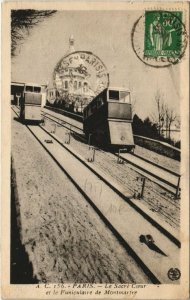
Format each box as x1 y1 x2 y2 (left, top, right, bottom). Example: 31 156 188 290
11 9 56 56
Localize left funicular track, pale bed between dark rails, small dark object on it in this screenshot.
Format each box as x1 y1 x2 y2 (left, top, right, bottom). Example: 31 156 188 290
11 106 180 284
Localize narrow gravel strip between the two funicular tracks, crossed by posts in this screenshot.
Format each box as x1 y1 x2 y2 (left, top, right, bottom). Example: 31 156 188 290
45 120 180 229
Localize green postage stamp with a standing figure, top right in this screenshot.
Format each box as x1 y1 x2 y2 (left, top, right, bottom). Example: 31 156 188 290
144 11 183 58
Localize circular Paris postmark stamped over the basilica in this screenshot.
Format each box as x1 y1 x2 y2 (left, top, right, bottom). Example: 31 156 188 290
53 51 109 96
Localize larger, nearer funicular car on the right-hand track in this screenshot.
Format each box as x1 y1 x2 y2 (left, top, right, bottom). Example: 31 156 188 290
83 87 135 151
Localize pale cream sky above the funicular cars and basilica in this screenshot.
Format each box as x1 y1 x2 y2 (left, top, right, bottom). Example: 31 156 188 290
11 11 184 119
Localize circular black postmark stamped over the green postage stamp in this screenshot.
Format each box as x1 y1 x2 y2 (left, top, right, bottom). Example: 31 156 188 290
131 10 188 68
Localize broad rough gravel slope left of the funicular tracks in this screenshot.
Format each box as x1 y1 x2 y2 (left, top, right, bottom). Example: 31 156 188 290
12 112 149 283
